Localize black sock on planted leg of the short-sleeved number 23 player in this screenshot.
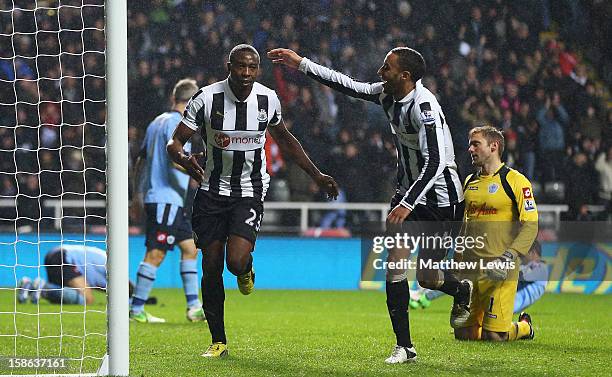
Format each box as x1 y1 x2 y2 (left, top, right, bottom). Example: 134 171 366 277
202 272 227 344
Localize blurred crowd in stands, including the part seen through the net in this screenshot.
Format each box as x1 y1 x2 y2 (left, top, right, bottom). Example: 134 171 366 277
0 0 612 228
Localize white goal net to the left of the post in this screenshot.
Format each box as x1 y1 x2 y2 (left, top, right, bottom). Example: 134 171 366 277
0 0 127 375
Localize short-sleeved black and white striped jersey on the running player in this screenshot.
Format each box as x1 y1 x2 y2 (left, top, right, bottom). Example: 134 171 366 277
182 79 281 201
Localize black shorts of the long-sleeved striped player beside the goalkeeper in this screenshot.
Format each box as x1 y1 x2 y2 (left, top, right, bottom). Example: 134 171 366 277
391 193 465 265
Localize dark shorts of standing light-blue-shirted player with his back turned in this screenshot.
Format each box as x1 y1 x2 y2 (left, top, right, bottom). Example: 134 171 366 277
145 203 192 250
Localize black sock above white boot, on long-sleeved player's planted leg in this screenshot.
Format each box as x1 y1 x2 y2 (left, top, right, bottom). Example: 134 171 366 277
386 279 412 347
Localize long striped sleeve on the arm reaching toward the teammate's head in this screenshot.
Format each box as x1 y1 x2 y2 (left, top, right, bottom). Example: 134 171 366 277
298 58 383 105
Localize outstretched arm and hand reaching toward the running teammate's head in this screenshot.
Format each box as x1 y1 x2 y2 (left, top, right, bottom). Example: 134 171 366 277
268 48 383 104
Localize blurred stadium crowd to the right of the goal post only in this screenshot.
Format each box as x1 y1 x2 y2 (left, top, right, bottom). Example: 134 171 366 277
129 0 612 217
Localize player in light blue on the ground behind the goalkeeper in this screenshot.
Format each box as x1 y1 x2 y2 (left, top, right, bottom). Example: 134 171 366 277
410 241 548 313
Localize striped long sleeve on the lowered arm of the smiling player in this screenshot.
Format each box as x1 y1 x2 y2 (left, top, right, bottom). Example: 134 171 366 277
400 102 446 210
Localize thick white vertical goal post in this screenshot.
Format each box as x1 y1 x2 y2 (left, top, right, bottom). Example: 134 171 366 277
106 0 130 376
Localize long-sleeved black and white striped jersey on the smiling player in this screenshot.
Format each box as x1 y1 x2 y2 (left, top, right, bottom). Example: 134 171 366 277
299 58 463 210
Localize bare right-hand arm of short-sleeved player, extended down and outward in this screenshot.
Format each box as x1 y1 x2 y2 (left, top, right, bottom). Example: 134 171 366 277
268 121 338 199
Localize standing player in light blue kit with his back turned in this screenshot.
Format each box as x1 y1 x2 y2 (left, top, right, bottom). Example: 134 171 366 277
130 79 205 323
